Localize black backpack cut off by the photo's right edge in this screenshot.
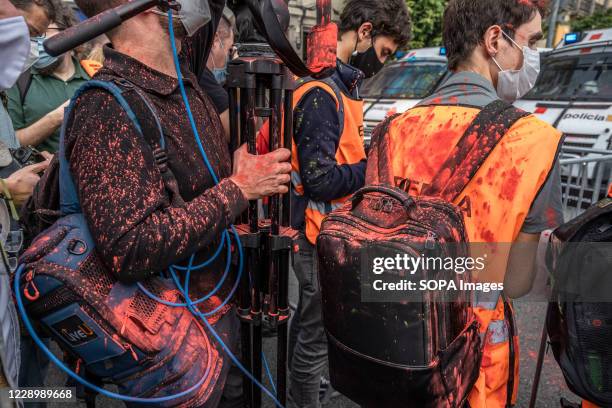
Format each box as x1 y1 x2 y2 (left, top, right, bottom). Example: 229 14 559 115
546 198 612 407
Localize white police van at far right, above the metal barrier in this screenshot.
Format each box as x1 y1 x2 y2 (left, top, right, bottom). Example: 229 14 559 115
515 28 612 150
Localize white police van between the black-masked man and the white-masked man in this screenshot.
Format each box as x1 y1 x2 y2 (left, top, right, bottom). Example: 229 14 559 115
361 47 449 146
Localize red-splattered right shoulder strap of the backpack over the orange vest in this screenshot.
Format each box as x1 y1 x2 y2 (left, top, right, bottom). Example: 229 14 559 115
423 100 529 202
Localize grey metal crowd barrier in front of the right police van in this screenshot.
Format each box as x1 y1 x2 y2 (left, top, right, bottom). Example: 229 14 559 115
560 147 612 221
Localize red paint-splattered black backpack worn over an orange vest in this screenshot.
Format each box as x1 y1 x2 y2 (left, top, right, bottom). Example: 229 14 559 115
317 101 526 408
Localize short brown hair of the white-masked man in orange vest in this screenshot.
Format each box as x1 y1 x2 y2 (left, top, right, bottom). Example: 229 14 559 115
442 0 547 70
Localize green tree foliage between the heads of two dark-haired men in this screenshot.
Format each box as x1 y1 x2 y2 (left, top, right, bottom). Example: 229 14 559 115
406 0 447 49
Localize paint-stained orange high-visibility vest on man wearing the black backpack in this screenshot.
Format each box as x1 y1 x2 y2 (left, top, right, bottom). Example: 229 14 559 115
378 105 561 408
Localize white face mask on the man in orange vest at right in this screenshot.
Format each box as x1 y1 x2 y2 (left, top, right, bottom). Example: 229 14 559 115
491 31 540 103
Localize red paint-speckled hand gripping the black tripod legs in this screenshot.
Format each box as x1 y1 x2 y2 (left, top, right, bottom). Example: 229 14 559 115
230 145 291 200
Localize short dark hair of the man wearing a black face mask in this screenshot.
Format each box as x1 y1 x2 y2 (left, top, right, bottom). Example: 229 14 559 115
338 0 412 48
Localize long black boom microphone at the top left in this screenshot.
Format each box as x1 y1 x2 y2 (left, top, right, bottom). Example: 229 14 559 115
43 0 180 57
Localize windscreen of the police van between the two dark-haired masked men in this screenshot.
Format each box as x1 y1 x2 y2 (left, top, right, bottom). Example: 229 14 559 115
361 62 447 99
